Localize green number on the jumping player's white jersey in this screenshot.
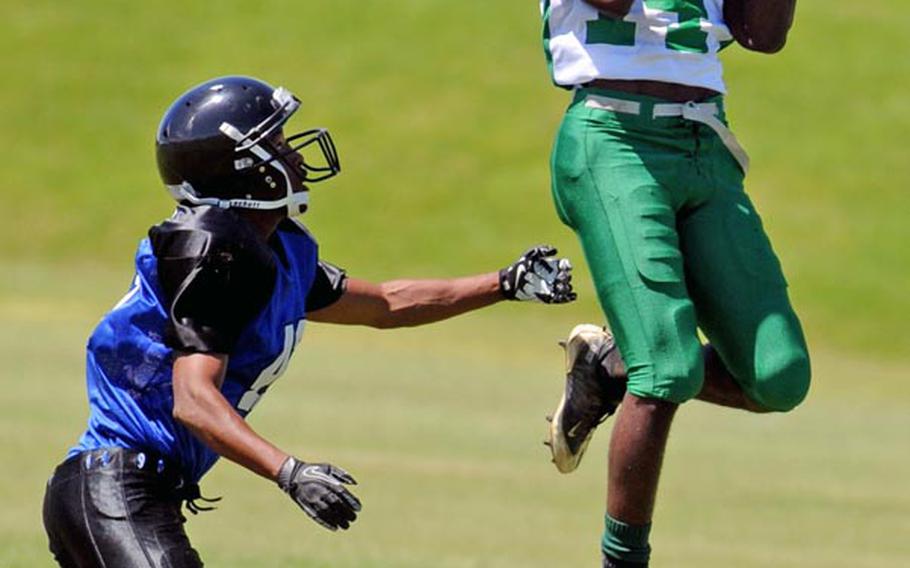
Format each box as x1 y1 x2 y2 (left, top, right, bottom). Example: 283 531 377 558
587 0 708 53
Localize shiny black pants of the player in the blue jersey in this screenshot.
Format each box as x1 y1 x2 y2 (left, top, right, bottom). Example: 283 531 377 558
44 448 202 568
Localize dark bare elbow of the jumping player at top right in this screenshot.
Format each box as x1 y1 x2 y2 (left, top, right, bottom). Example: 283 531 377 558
724 0 796 53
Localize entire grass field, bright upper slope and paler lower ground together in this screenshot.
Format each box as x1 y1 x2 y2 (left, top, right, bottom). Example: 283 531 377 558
0 0 910 568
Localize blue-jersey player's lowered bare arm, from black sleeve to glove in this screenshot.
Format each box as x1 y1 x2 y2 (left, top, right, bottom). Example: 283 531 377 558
173 353 288 481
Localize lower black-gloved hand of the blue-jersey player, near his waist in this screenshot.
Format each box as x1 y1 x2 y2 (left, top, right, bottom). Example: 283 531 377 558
278 457 360 531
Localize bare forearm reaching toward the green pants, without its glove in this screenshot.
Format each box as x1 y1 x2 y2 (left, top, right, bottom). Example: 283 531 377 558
308 272 505 329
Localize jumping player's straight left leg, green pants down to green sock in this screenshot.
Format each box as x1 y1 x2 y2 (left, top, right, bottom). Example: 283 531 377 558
553 89 703 565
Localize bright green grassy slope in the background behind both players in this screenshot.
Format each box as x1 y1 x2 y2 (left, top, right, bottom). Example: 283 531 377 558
0 0 910 359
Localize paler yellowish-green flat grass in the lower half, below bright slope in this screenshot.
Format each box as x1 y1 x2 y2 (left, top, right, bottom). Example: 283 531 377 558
0 265 910 568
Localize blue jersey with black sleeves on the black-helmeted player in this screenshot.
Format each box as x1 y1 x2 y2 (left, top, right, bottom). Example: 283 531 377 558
69 208 343 482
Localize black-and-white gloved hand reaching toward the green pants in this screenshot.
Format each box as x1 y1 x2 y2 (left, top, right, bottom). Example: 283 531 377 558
499 245 576 304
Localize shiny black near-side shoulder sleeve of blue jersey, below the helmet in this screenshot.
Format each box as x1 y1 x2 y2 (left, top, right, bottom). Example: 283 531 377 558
149 220 275 354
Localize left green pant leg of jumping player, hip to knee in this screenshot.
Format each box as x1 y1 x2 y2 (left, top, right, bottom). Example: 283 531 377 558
552 89 703 408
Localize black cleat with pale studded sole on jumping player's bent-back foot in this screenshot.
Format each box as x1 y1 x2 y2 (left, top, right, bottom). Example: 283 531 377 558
547 324 625 473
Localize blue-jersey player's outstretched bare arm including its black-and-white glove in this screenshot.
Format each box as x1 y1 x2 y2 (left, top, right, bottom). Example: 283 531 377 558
307 246 575 329
